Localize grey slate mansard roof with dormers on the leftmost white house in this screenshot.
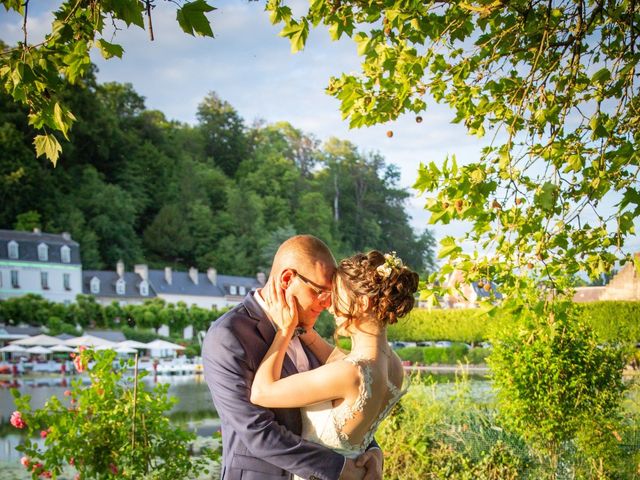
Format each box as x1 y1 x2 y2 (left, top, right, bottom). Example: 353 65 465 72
0 230 82 265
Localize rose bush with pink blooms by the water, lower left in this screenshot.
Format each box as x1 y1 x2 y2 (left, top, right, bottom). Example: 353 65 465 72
11 350 215 479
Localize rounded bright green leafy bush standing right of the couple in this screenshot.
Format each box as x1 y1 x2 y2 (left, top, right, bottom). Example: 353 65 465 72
489 302 626 472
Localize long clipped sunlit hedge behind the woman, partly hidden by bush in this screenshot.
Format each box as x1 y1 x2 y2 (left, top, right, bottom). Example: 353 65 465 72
389 301 640 344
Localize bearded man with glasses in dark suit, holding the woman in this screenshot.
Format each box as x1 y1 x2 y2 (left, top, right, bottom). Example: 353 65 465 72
202 235 382 480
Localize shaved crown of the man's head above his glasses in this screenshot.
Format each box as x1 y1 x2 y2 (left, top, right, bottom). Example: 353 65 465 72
271 235 336 275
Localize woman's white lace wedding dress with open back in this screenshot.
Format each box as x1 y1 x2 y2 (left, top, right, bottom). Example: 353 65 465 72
294 356 406 480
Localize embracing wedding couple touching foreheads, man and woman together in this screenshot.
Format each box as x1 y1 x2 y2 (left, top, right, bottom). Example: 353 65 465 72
202 235 418 480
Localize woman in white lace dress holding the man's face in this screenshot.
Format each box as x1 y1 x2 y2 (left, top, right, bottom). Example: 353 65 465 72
251 250 418 474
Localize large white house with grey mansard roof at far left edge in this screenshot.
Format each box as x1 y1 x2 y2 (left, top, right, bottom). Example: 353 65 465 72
0 229 82 304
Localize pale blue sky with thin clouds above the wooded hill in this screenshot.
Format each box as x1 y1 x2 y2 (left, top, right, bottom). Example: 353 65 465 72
0 0 640 255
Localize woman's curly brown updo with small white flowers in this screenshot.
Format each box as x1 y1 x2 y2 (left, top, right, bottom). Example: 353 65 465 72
333 250 418 325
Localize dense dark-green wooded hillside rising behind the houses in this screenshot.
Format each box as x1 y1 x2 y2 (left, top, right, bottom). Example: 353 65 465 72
0 67 435 276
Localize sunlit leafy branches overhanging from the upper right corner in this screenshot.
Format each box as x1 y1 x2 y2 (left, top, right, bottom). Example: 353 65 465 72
267 0 640 300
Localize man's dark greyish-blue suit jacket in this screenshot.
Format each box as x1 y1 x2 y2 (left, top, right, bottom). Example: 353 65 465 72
202 293 344 480
